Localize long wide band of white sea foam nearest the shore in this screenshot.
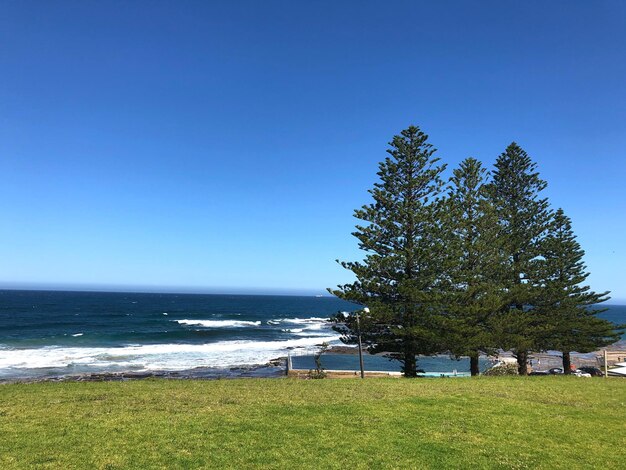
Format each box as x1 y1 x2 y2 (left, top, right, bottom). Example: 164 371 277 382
0 335 339 373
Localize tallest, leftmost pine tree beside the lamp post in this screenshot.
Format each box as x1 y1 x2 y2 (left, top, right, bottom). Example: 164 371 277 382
330 126 444 377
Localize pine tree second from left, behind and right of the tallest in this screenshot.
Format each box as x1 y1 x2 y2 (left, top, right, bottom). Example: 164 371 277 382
442 158 504 376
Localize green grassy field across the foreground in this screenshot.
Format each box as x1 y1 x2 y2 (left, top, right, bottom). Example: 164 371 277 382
0 377 626 469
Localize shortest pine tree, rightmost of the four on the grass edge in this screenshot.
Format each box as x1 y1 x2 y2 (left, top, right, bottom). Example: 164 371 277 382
539 209 620 374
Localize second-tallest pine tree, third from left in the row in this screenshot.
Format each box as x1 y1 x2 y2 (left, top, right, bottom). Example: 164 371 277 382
490 142 550 375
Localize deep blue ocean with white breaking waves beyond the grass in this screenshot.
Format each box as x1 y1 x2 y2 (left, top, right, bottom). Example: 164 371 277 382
0 290 626 380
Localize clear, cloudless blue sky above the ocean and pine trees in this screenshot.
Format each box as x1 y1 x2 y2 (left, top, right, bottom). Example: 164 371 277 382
0 0 626 301
